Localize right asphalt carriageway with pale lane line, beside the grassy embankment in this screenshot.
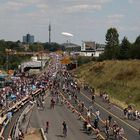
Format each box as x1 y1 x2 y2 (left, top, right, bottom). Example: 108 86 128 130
78 90 140 140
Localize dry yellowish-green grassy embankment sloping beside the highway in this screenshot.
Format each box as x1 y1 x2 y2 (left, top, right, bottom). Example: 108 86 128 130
73 60 140 110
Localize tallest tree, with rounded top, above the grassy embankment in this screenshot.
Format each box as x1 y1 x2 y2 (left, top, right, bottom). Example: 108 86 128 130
104 28 119 59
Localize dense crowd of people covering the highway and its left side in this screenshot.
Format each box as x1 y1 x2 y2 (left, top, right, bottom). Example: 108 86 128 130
0 53 140 139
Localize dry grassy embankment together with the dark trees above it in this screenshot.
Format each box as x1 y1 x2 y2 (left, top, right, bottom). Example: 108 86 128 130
71 28 140 109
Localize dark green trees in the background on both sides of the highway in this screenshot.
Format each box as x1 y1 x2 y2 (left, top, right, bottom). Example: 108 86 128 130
0 28 140 69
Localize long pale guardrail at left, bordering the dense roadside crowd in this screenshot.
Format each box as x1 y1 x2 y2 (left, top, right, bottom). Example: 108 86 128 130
0 88 47 137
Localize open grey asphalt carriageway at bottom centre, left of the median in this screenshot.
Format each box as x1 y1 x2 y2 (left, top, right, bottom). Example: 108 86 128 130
29 96 96 140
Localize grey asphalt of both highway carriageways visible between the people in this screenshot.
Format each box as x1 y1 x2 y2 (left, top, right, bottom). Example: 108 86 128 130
30 53 140 140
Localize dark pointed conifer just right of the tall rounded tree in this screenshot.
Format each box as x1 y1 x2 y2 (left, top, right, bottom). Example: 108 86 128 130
119 37 131 59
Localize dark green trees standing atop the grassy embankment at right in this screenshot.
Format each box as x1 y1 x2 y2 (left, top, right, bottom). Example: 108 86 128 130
99 28 140 60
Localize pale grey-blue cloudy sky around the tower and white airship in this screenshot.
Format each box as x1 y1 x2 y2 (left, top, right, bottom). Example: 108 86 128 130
0 0 140 45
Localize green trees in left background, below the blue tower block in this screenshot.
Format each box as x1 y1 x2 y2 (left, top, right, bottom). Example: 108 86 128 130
0 40 64 70
